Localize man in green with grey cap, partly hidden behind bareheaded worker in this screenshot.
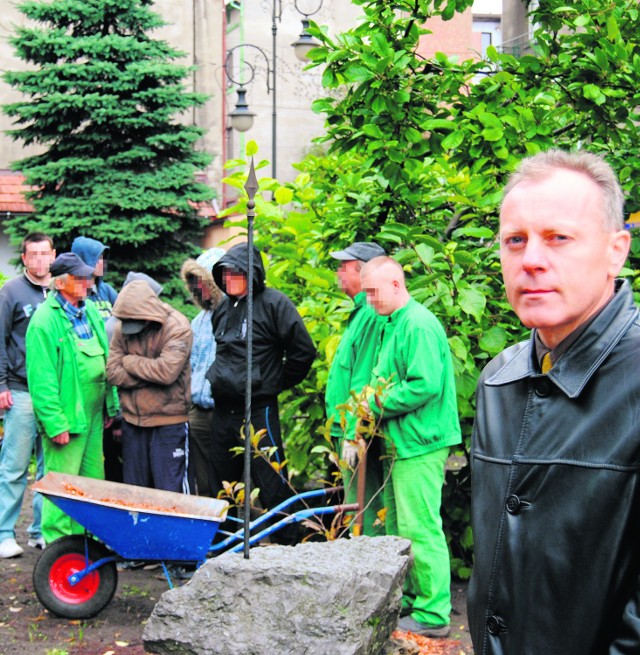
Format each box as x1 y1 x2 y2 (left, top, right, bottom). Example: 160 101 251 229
325 241 385 536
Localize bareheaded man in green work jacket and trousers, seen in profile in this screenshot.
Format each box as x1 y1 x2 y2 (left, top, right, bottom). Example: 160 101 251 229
361 257 461 637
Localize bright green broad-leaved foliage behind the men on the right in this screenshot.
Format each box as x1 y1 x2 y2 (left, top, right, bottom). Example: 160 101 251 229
224 0 640 577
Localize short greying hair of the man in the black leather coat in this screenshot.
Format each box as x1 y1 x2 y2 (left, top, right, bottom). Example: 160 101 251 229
502 148 624 232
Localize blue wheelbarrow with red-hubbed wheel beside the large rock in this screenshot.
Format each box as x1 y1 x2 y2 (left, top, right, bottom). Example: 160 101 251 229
32 473 359 619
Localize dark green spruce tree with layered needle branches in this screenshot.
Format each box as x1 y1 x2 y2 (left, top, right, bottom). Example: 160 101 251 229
4 0 212 296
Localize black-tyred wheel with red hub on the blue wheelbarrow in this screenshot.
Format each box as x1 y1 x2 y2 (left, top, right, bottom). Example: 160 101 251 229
33 535 118 619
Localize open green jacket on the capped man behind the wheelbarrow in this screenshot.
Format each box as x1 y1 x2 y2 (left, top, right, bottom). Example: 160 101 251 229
26 293 119 438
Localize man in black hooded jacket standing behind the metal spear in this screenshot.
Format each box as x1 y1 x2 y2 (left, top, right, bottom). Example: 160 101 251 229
207 243 316 544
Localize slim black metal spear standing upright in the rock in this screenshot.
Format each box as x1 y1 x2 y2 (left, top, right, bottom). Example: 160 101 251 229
244 157 258 559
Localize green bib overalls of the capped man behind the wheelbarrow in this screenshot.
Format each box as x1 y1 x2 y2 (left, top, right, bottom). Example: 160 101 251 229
42 335 106 544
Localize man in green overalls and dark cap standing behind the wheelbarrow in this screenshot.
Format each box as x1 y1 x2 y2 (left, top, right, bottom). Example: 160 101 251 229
26 253 118 544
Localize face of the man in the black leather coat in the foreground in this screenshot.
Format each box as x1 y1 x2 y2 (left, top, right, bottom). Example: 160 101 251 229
500 169 629 348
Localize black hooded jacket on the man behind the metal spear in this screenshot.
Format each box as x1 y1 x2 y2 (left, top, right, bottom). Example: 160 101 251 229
207 243 316 410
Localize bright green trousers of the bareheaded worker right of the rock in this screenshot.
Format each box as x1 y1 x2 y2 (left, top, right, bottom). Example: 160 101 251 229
384 448 451 625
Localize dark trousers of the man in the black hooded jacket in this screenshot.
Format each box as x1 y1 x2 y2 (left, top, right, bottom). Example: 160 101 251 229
212 402 298 545
